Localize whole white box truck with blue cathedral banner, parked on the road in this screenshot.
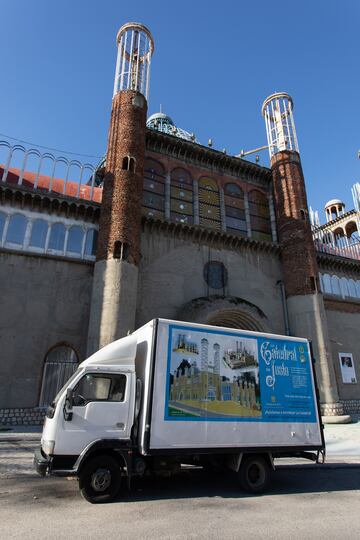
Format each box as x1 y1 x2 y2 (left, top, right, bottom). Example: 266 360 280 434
34 319 325 502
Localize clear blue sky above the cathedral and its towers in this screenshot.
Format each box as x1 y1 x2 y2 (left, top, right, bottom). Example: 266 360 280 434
0 0 360 220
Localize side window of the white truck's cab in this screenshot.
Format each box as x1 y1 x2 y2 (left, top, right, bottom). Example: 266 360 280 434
73 373 126 406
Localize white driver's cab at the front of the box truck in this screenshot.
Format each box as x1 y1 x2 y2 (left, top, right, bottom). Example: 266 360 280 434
35 336 140 502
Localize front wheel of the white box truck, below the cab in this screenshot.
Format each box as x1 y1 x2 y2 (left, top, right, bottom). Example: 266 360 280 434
79 455 121 503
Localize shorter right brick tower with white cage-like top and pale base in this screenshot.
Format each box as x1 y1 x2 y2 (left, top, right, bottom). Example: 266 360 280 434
262 92 343 416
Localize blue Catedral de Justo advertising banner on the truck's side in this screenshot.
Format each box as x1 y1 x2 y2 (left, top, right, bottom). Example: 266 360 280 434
164 325 316 423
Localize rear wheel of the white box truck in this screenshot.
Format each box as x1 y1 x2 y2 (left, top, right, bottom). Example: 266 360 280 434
239 455 270 493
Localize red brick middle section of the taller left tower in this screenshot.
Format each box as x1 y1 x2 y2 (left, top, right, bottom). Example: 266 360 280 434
97 90 147 264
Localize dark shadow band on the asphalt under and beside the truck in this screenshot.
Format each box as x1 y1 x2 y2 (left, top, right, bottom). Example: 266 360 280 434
0 465 360 507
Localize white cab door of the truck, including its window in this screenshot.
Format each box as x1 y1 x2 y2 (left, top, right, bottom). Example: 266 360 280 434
55 372 135 455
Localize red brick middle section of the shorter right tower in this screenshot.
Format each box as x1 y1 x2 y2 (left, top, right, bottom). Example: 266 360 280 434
271 151 318 296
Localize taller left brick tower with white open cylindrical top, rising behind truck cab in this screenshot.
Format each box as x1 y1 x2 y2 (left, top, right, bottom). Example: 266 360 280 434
88 23 154 354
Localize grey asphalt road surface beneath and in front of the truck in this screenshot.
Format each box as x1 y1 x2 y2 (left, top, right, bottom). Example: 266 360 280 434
0 442 360 540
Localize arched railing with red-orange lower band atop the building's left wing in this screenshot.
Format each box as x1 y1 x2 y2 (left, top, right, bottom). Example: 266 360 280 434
0 141 102 202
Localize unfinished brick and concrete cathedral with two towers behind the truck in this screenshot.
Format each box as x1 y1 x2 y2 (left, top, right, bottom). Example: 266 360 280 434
0 23 360 425
